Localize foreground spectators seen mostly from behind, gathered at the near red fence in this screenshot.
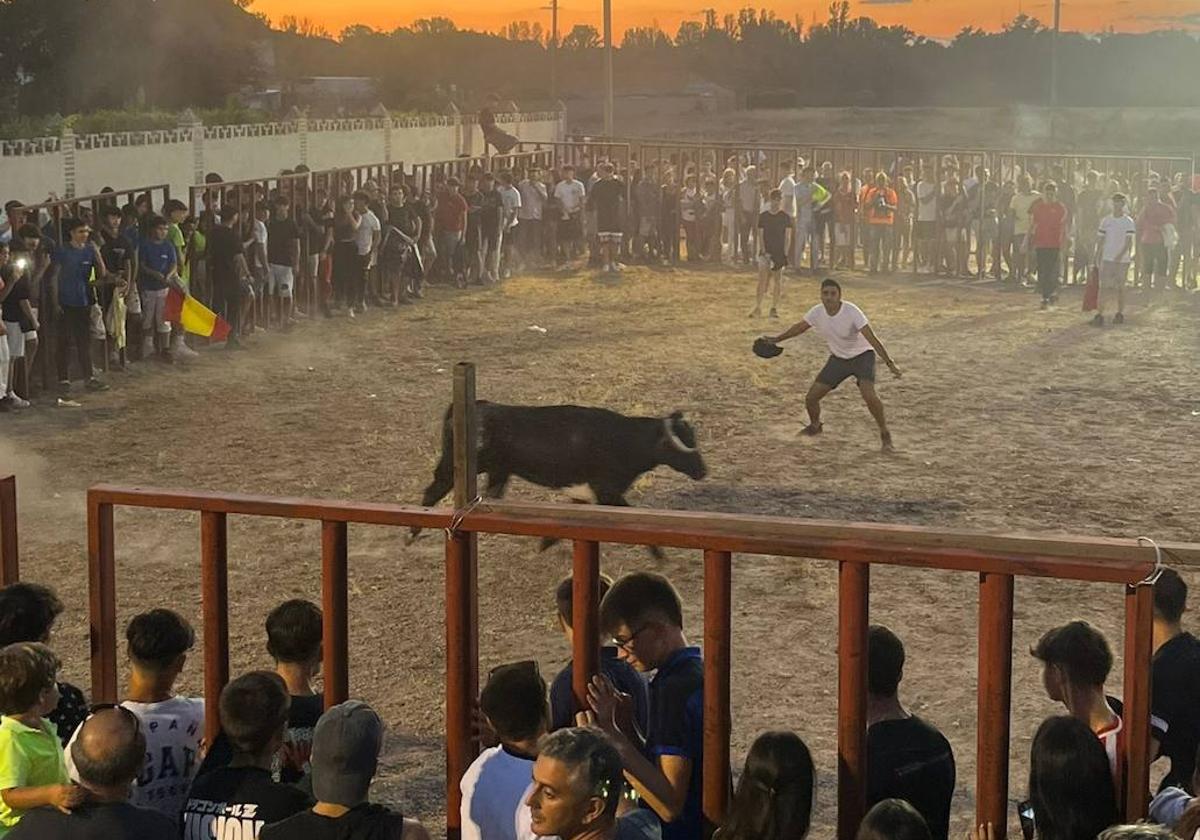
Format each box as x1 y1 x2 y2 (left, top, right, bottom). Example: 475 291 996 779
0 556 1200 840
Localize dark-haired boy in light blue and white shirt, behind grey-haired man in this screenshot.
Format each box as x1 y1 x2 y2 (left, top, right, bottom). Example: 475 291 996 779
458 660 550 840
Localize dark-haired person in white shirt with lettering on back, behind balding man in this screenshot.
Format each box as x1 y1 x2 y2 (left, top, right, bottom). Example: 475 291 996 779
66 610 204 822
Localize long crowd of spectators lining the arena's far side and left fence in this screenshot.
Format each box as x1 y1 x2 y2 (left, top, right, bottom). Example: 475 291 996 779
0 154 1200 412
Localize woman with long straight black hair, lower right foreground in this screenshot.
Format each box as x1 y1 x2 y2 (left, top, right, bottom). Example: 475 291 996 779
1030 716 1117 840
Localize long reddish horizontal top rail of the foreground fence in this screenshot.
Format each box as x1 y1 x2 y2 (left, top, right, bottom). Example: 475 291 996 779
82 485 1200 583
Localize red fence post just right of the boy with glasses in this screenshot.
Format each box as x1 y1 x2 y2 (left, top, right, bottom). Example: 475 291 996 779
703 551 733 836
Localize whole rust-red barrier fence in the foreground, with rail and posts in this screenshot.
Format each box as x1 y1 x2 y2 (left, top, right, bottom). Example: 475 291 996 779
75 365 1200 840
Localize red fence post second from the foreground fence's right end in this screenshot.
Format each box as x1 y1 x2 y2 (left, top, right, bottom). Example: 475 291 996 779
976 574 1013 840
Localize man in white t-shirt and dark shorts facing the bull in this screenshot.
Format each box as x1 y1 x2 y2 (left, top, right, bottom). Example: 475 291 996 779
763 277 900 452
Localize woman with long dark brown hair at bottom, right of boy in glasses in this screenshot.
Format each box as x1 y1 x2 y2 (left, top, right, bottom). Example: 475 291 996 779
716 731 816 840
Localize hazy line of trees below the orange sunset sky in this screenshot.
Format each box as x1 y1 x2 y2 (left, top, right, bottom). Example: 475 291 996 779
0 0 1200 114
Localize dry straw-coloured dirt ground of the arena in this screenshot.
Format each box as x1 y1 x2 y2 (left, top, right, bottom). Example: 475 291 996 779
0 260 1200 838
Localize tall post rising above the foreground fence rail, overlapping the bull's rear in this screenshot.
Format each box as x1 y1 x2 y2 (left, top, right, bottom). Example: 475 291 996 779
445 362 479 840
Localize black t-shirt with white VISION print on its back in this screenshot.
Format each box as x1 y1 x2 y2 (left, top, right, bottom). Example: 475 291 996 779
182 767 312 838
